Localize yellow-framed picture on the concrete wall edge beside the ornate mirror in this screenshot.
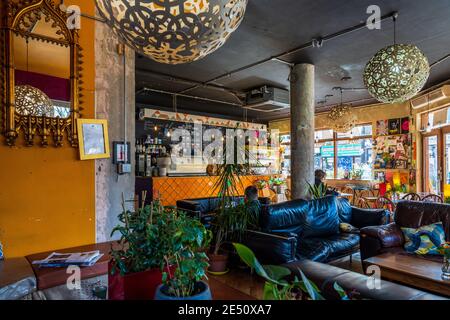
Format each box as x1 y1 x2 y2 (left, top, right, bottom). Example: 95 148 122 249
77 119 110 160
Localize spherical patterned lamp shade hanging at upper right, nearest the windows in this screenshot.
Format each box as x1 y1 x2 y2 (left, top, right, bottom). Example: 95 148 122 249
364 44 430 103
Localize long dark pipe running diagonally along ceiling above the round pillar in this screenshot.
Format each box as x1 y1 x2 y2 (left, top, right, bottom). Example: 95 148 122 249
179 12 398 93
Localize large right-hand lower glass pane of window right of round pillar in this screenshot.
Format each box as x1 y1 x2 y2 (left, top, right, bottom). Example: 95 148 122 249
337 139 373 180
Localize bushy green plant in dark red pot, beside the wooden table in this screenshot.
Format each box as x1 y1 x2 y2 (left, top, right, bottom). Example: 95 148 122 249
108 199 178 300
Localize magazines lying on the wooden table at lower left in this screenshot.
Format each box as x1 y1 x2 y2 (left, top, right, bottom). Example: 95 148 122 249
33 250 103 267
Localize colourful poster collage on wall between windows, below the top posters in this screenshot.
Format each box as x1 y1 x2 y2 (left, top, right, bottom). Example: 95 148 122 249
374 134 411 169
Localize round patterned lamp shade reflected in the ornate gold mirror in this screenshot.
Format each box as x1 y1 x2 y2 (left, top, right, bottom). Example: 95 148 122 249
14 85 55 117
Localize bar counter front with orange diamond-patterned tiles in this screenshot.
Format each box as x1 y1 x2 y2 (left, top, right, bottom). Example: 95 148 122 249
136 175 278 206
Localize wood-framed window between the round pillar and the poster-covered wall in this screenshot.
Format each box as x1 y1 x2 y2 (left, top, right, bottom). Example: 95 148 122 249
314 125 373 180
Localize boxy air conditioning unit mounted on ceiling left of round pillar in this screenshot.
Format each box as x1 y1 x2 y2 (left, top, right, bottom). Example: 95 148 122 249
244 86 290 112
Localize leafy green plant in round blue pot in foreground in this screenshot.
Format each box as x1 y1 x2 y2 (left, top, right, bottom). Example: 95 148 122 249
155 213 211 300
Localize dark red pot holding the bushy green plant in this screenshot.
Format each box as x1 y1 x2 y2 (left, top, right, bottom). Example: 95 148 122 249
108 263 175 300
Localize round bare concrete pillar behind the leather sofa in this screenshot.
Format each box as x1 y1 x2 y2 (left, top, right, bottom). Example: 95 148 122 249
290 64 315 199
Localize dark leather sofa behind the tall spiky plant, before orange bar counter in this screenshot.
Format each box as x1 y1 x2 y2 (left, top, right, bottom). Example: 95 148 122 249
177 196 270 227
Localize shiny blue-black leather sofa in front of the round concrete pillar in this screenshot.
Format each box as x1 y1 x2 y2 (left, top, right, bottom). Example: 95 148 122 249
244 196 389 264
